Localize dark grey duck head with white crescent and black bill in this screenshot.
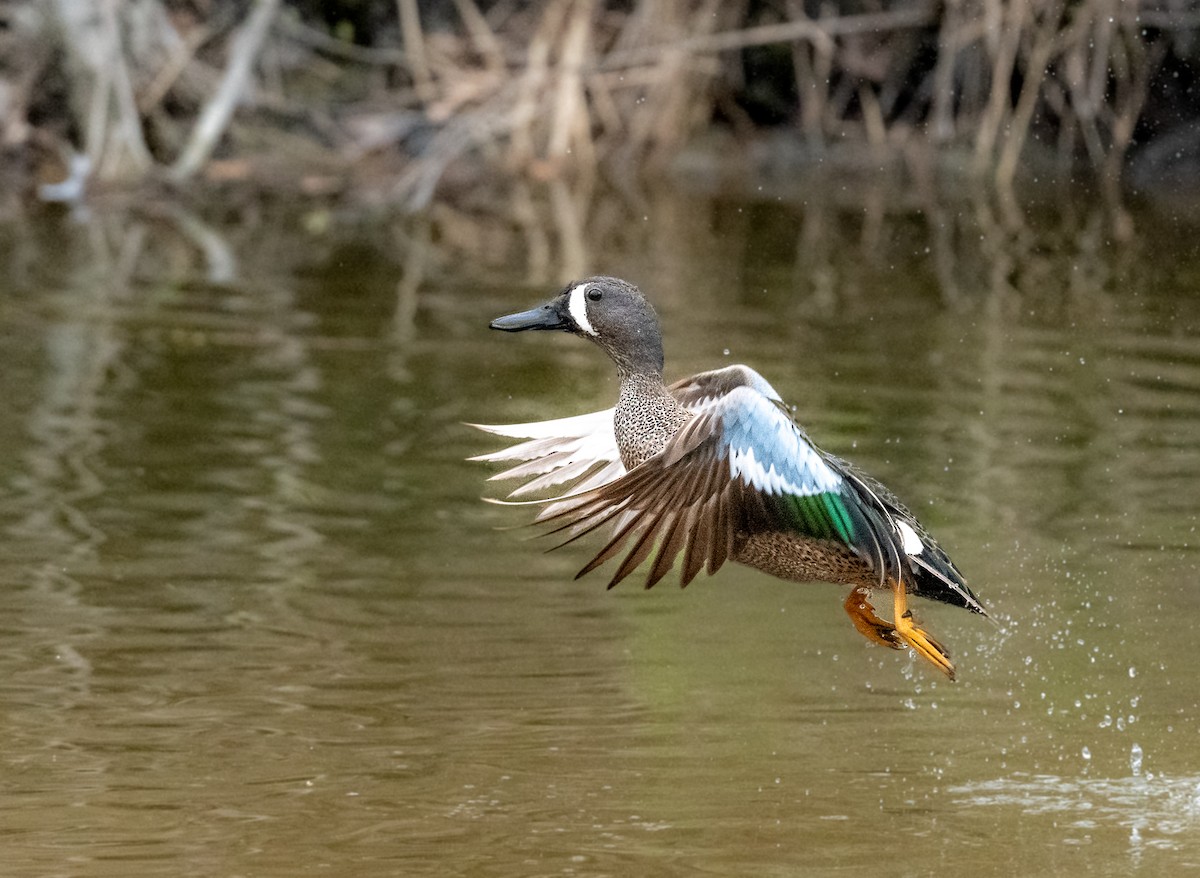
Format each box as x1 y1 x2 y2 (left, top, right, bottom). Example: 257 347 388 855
491 277 662 375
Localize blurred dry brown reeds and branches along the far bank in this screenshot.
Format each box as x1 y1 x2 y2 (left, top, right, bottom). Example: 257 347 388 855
0 0 1200 208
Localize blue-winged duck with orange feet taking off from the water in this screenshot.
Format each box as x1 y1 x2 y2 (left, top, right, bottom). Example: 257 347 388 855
469 276 988 680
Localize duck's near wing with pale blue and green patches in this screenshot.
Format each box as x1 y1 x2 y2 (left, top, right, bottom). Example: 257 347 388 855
540 381 890 587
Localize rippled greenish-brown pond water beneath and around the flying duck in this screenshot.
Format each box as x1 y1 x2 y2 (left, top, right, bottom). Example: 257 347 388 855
0 182 1200 876
